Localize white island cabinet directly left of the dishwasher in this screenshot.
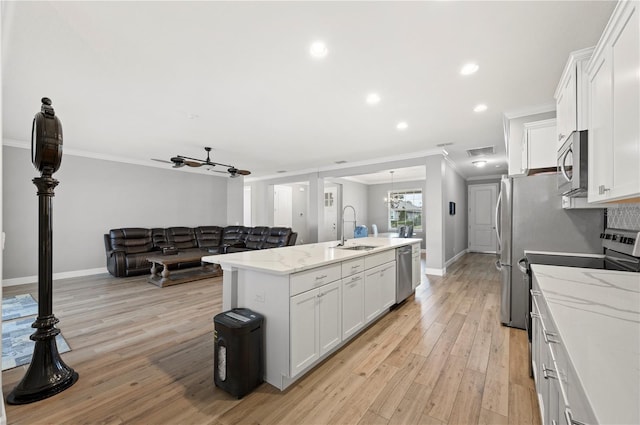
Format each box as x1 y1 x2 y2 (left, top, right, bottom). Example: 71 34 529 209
364 261 396 323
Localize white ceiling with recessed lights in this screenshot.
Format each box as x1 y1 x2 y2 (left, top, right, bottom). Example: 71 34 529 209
2 1 615 182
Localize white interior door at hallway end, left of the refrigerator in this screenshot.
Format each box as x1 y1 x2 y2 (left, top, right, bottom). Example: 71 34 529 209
468 183 498 253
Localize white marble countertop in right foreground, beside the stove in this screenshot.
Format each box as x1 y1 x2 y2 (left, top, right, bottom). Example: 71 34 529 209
531 264 640 424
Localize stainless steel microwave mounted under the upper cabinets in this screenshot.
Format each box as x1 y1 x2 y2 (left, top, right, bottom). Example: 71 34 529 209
558 130 589 197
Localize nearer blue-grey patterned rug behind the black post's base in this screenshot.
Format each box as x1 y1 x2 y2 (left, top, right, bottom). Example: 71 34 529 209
2 317 71 370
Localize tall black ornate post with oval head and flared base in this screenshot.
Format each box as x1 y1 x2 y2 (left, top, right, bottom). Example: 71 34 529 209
7 97 78 404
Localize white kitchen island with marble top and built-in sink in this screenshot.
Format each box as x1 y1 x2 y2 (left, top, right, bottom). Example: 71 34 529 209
202 238 421 390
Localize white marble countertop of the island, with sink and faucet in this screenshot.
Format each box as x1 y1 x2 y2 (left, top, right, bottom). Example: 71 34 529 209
202 237 422 275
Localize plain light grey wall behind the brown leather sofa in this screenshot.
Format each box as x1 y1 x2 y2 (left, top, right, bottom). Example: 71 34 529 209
2 146 228 281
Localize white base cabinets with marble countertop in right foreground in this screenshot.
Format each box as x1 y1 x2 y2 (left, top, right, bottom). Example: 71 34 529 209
531 264 640 424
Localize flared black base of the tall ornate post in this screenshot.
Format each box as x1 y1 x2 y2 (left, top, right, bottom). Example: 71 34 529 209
7 319 79 404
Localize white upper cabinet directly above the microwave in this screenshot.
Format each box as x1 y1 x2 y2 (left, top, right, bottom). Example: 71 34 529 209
554 47 594 149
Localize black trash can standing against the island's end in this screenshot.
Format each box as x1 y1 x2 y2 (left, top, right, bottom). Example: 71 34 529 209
213 308 264 398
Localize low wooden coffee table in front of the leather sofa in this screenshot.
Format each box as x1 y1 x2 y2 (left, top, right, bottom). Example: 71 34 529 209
147 252 222 288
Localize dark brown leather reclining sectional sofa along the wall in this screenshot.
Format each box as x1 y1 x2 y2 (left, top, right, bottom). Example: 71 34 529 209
104 226 298 277
